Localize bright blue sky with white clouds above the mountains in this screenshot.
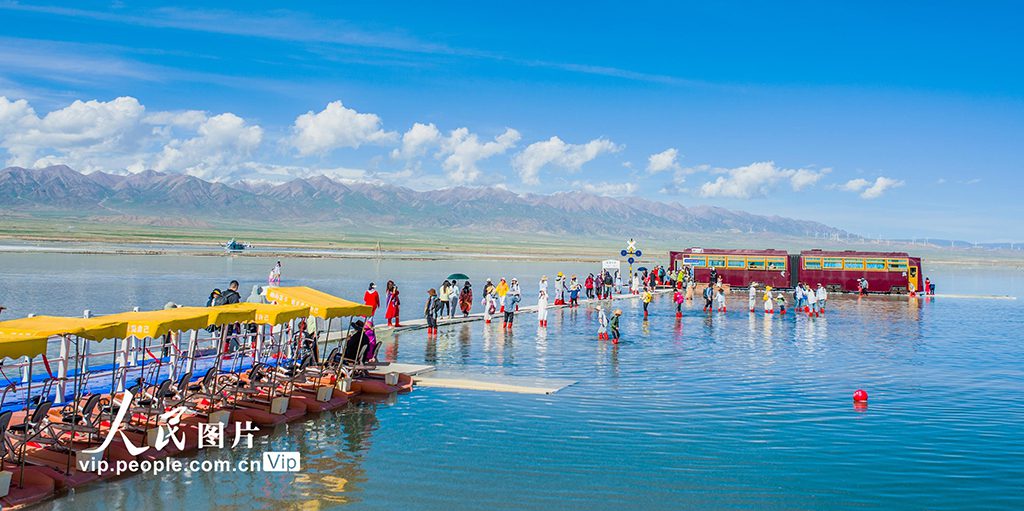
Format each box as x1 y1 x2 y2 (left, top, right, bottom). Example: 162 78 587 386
0 0 1024 242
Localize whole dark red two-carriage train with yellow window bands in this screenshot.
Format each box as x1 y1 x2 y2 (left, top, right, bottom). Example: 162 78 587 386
669 248 922 293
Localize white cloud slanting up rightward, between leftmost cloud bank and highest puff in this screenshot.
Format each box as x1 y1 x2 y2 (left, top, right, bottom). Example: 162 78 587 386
152 113 263 180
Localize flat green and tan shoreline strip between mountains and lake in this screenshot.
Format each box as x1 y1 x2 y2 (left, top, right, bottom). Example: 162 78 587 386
0 227 1024 269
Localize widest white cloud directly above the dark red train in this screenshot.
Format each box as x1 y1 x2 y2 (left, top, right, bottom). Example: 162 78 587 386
700 162 829 199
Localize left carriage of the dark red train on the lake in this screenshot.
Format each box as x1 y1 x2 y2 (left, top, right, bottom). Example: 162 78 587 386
669 248 792 288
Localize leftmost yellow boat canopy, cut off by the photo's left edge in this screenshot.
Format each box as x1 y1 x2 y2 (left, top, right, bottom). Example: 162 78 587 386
0 315 126 358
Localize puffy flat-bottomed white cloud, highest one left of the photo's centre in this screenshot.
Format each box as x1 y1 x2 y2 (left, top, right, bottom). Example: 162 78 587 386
291 101 398 156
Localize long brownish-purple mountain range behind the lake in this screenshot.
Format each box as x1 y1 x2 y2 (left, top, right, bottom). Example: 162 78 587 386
0 165 857 238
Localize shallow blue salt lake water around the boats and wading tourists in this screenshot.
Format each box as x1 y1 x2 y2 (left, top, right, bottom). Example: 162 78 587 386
0 254 1024 511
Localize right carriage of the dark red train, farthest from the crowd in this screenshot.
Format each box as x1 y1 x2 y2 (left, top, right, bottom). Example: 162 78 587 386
797 249 922 293
